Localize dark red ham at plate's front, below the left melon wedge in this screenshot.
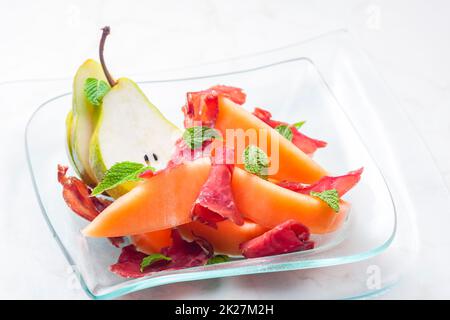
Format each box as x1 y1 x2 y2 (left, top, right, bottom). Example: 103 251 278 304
110 230 212 278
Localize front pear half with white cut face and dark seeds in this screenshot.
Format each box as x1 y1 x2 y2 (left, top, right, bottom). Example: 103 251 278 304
89 78 181 198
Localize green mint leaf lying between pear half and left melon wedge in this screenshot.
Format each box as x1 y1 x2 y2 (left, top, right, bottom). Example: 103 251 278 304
91 161 155 196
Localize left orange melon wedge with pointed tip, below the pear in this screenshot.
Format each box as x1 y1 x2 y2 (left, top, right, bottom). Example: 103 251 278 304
83 158 211 237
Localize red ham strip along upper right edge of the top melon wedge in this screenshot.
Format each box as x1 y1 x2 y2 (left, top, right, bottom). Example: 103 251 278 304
253 108 327 157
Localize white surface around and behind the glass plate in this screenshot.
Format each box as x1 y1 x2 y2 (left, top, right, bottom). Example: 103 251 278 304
0 0 450 299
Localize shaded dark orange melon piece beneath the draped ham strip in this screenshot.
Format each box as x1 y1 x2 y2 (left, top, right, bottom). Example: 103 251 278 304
178 220 268 256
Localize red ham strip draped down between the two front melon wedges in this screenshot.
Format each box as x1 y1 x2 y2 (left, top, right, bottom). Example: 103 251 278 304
192 146 244 228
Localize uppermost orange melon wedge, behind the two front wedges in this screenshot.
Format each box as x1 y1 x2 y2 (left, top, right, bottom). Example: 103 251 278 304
215 97 327 183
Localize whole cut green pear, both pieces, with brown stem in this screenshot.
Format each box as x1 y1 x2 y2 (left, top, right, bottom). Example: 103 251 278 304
66 27 181 198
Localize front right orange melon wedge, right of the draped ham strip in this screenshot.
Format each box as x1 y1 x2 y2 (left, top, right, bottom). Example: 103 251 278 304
231 168 345 234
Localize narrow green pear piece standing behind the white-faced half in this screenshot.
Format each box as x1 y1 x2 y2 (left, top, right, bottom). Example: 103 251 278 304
66 59 106 187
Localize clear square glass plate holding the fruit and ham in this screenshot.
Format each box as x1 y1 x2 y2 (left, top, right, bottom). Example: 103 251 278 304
26 32 426 299
